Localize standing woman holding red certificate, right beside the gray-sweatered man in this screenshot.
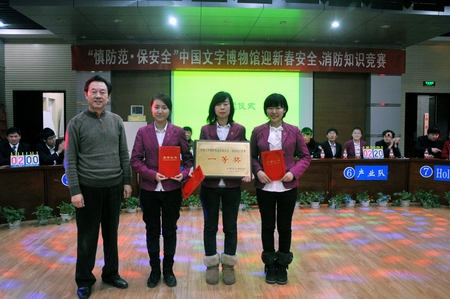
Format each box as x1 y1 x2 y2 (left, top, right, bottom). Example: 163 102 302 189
130 93 193 288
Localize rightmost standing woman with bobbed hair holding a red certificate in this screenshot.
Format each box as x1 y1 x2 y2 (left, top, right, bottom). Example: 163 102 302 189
250 93 311 284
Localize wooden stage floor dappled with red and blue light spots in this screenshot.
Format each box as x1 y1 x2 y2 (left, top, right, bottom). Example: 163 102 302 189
0 206 450 299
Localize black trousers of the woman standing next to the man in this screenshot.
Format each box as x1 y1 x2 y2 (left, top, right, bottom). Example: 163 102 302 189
140 188 182 258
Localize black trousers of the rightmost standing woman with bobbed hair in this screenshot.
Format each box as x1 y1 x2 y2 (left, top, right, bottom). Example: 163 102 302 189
256 188 297 253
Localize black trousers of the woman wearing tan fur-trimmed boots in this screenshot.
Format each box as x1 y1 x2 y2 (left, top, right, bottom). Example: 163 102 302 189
200 186 241 256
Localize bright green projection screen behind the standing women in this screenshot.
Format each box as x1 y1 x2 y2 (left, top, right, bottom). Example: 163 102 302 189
172 71 300 140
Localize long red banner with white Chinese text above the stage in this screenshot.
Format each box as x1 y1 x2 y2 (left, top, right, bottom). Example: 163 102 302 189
72 45 406 74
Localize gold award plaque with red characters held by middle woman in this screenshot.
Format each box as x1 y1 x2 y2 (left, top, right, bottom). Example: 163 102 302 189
194 140 252 179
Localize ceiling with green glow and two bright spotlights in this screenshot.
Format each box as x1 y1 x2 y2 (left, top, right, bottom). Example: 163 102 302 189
5 0 450 49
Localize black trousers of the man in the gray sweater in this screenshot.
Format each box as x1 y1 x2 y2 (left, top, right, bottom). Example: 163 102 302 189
75 184 124 287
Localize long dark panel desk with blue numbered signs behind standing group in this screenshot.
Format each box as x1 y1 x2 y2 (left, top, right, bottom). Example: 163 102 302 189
0 158 450 223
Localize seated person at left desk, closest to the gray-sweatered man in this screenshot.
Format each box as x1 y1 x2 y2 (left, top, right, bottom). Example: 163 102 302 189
36 128 64 165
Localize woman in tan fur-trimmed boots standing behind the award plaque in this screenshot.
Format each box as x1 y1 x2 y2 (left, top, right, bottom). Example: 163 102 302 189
200 91 251 285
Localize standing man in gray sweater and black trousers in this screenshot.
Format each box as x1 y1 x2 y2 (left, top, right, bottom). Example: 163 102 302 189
64 76 131 299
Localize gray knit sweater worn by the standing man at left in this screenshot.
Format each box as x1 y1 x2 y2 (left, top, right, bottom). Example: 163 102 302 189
64 110 131 196
